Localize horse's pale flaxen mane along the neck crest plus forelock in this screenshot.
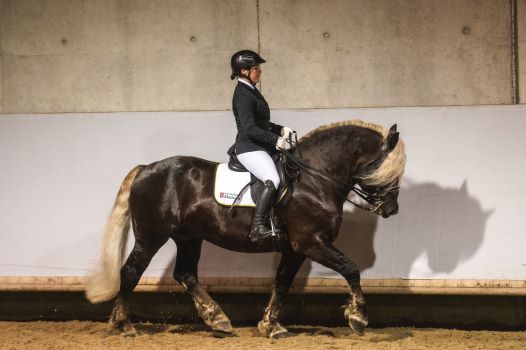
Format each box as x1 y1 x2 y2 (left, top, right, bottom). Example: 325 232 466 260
300 120 406 186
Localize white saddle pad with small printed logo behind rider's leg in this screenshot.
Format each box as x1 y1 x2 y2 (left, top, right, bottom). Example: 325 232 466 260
214 163 256 207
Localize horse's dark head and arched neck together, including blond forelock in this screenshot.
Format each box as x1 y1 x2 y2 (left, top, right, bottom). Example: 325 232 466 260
300 120 405 217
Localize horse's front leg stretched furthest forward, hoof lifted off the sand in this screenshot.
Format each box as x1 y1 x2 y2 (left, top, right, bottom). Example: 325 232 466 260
305 243 368 335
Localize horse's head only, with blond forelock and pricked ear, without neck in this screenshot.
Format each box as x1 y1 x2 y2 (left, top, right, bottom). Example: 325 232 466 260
353 124 405 218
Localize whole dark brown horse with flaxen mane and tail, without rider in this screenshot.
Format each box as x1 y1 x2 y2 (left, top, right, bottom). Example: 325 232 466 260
85 120 406 338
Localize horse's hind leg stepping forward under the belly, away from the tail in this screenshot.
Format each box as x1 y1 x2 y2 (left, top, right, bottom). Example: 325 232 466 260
174 238 234 333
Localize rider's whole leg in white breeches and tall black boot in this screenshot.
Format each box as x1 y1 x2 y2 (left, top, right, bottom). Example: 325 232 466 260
237 151 279 241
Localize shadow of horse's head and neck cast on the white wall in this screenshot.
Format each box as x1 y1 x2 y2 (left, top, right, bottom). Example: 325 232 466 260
274 180 492 278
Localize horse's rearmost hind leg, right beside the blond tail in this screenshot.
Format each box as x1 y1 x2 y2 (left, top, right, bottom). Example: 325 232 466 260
110 239 168 336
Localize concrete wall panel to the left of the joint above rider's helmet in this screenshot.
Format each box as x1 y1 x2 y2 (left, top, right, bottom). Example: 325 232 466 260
0 0 257 113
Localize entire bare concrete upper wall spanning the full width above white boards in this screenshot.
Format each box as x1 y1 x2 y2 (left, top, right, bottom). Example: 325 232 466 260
0 0 526 113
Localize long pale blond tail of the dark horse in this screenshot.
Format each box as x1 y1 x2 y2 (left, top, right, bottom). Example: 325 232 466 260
86 165 144 303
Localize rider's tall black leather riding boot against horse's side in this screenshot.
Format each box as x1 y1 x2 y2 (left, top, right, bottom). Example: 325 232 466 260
249 180 280 242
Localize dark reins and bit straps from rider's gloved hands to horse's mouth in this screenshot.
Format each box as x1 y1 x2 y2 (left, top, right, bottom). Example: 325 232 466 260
279 131 400 215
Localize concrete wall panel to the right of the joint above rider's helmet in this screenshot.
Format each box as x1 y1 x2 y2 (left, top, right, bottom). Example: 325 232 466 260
261 0 511 108
